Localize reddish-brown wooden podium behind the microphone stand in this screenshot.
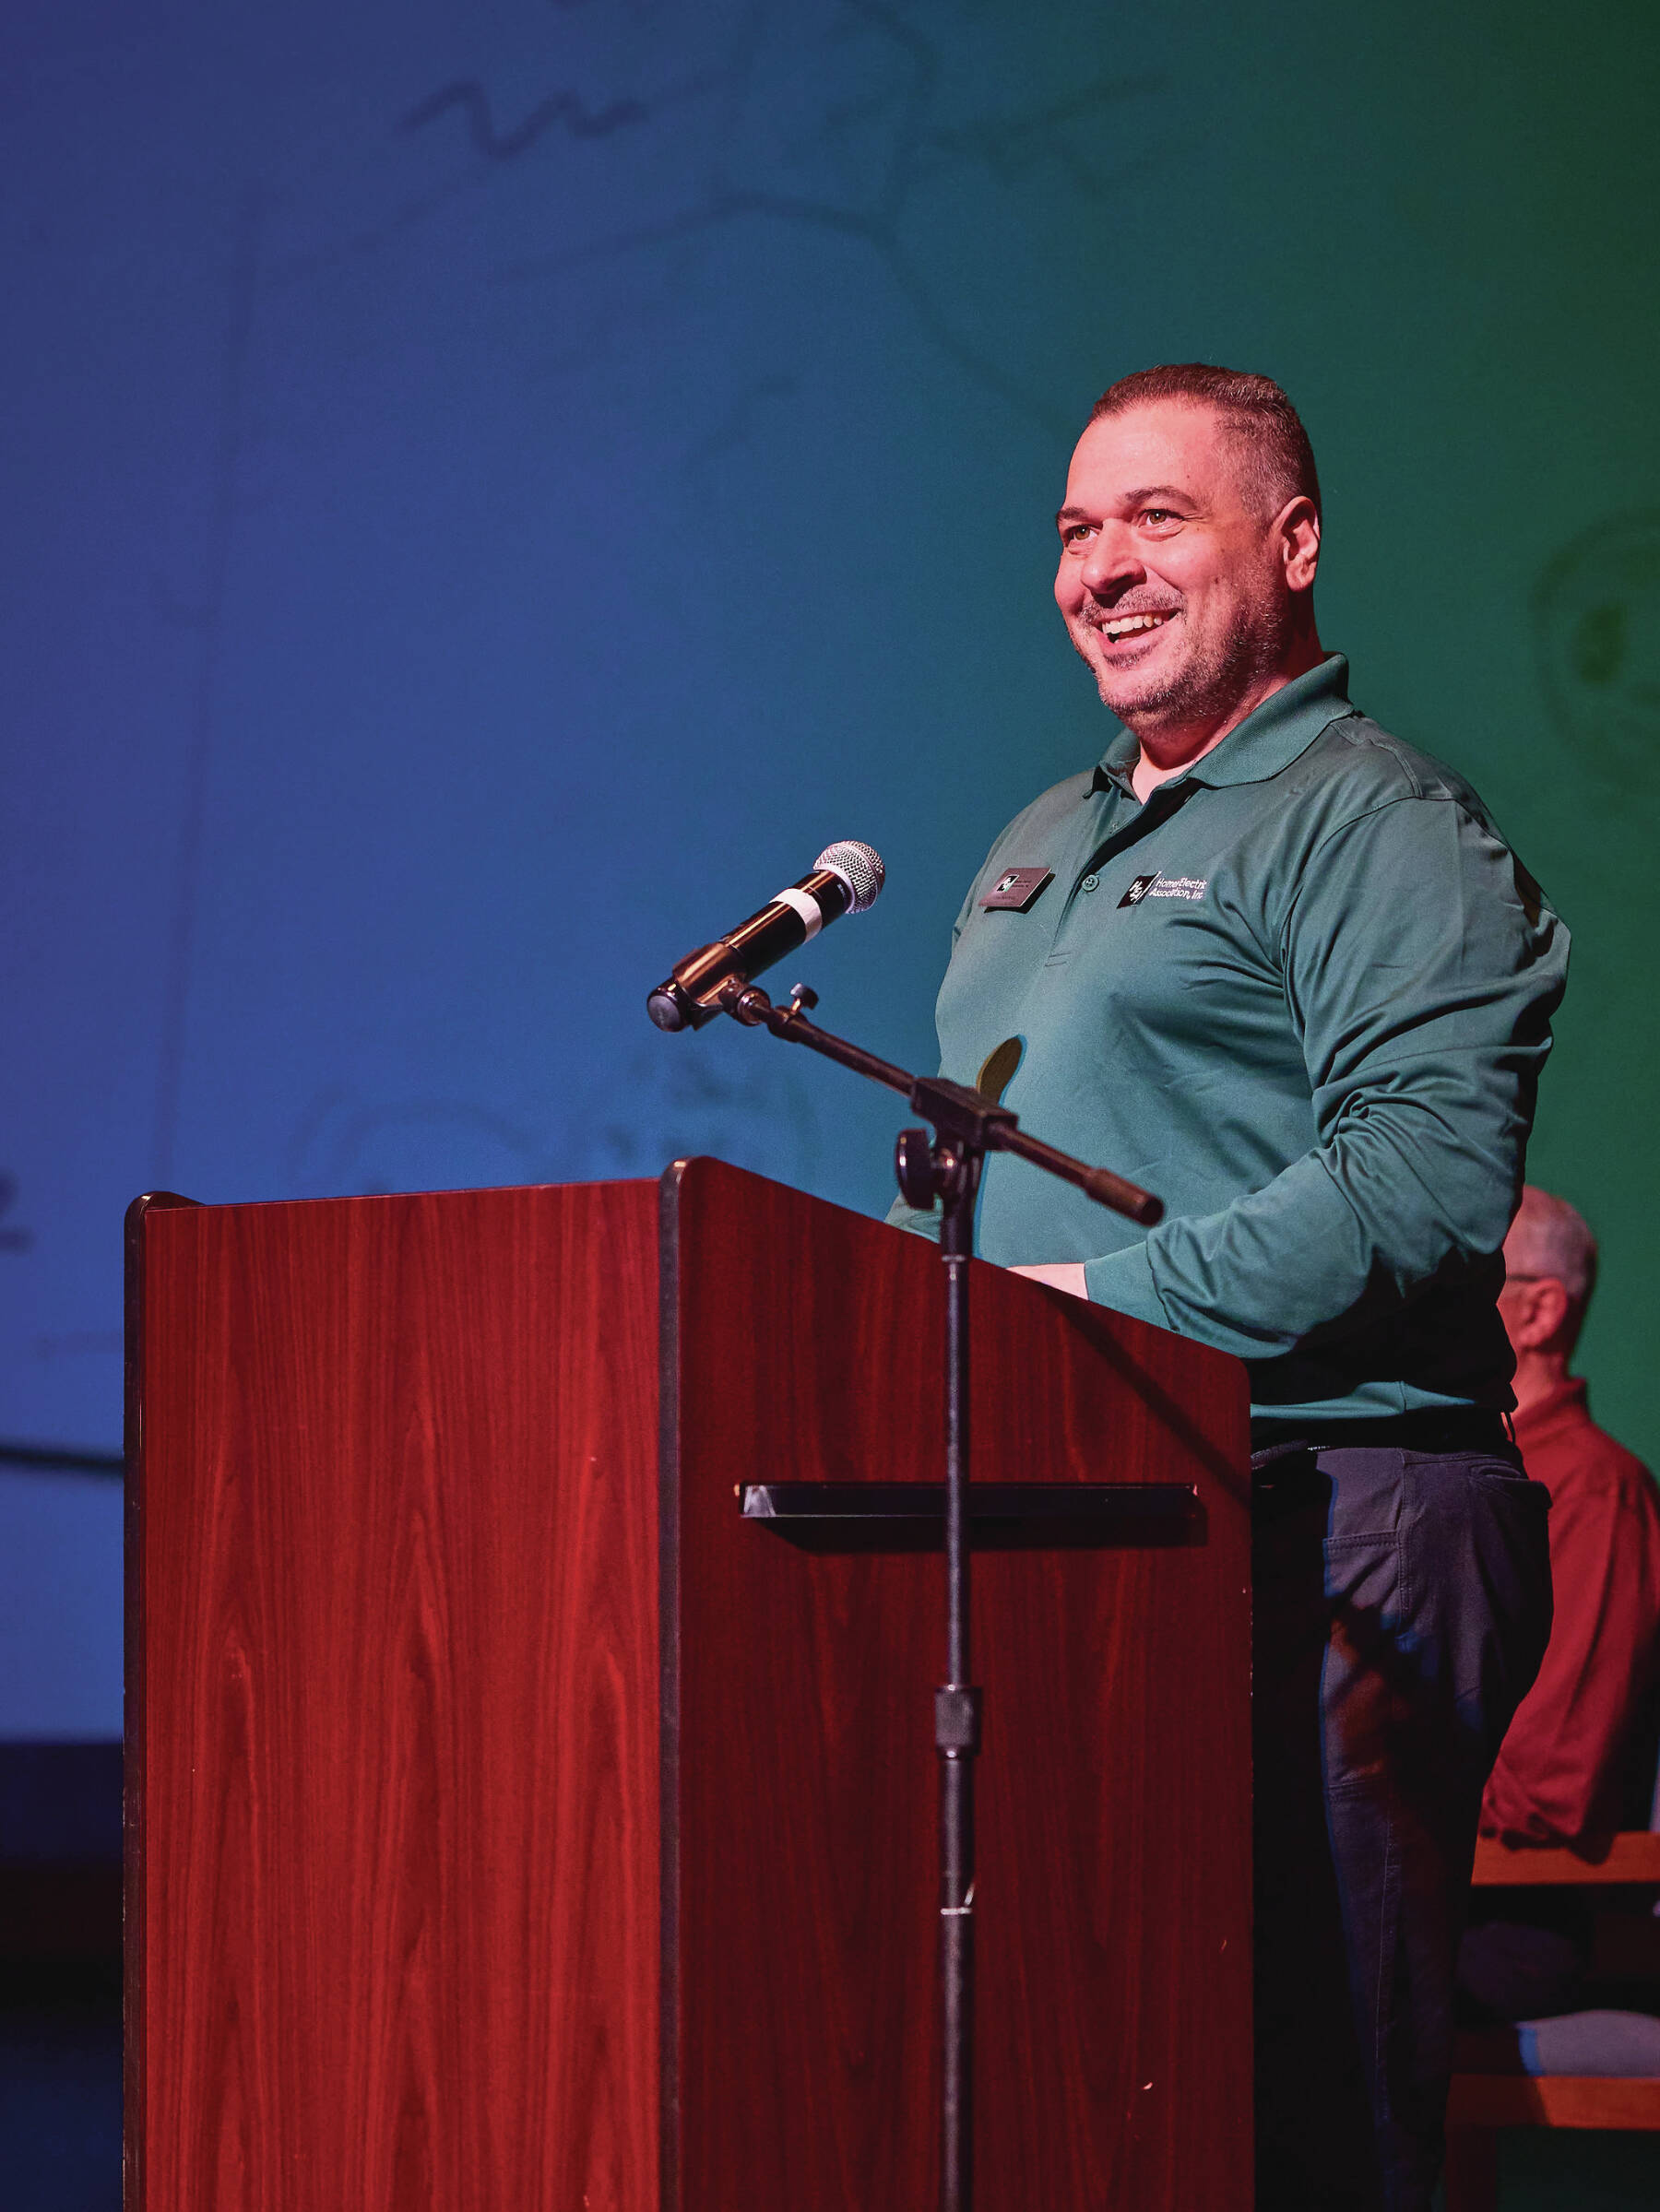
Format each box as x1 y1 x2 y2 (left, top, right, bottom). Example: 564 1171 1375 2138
126 1159 1251 2212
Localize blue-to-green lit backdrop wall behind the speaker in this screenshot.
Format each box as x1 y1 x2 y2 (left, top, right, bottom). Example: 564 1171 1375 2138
0 0 1660 1734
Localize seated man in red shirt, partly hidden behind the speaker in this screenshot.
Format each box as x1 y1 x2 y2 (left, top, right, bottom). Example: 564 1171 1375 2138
1459 1186 1660 2035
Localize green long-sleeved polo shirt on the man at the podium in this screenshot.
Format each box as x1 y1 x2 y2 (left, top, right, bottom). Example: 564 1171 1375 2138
890 655 1567 1420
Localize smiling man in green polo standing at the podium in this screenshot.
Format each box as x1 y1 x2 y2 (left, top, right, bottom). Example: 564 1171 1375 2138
892 365 1567 2212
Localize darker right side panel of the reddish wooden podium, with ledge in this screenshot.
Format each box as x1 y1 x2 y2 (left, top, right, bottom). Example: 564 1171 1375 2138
664 1161 1251 2212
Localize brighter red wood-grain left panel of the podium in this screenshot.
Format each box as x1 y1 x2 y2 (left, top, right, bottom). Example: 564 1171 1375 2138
128 1183 658 2212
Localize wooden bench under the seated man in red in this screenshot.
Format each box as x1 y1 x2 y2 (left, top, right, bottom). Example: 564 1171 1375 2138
1448 1834 1660 2212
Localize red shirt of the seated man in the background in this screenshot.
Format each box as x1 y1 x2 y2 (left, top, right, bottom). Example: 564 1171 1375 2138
1481 1378 1660 1842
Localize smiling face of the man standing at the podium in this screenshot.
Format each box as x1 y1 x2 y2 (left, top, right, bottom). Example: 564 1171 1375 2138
1056 400 1319 737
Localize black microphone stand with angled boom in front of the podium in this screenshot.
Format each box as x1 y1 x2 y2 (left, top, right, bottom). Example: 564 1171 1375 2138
699 976 1164 2212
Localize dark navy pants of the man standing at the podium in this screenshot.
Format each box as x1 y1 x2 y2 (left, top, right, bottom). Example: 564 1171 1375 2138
1252 1445 1551 2212
